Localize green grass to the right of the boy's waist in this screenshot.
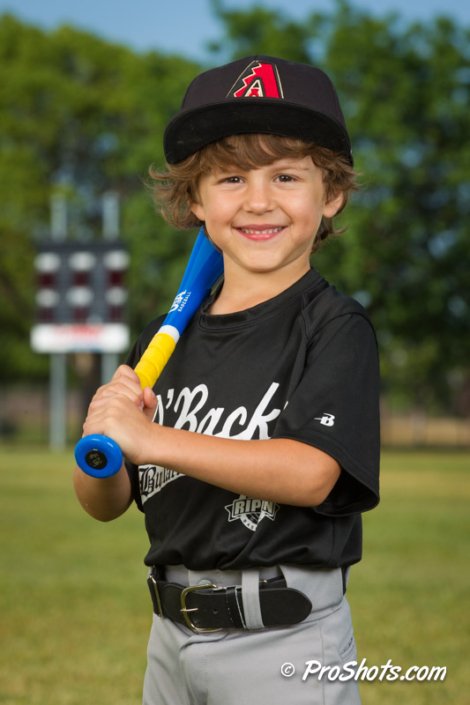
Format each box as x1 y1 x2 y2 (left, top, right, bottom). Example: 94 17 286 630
348 452 470 705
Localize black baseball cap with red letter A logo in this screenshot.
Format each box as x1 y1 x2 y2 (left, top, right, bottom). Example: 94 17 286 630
163 56 352 164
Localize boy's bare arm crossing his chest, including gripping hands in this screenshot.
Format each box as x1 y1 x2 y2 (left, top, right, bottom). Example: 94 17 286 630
79 367 340 506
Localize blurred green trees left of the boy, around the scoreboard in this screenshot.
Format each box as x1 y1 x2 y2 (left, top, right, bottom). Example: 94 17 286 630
0 15 199 379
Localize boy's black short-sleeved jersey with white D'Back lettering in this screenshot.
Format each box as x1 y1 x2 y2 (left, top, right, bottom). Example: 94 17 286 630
128 270 379 570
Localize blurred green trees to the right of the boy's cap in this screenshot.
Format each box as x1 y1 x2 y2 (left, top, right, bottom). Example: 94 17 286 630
212 0 470 412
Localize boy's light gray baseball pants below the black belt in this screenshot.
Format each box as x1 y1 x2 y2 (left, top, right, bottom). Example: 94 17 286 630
143 566 360 705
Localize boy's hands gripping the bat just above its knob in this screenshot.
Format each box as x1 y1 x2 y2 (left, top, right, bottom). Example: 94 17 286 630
83 365 157 464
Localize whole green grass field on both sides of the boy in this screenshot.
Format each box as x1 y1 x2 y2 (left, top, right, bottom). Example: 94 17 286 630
0 448 470 705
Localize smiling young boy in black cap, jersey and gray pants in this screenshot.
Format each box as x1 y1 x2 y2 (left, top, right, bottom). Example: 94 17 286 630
75 56 379 705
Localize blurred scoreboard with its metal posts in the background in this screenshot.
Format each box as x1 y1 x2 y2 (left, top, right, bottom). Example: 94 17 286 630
31 192 129 448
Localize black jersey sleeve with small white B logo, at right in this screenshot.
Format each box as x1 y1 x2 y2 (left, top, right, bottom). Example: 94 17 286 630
273 313 380 516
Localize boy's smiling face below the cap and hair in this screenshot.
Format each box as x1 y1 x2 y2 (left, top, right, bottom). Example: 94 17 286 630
192 157 343 278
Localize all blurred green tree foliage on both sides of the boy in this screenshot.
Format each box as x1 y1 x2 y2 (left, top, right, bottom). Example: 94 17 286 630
0 0 470 408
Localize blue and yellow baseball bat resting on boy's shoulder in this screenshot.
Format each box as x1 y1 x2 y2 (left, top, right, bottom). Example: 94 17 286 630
75 228 223 478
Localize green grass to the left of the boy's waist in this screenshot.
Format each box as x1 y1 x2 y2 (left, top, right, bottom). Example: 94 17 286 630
0 450 151 705
